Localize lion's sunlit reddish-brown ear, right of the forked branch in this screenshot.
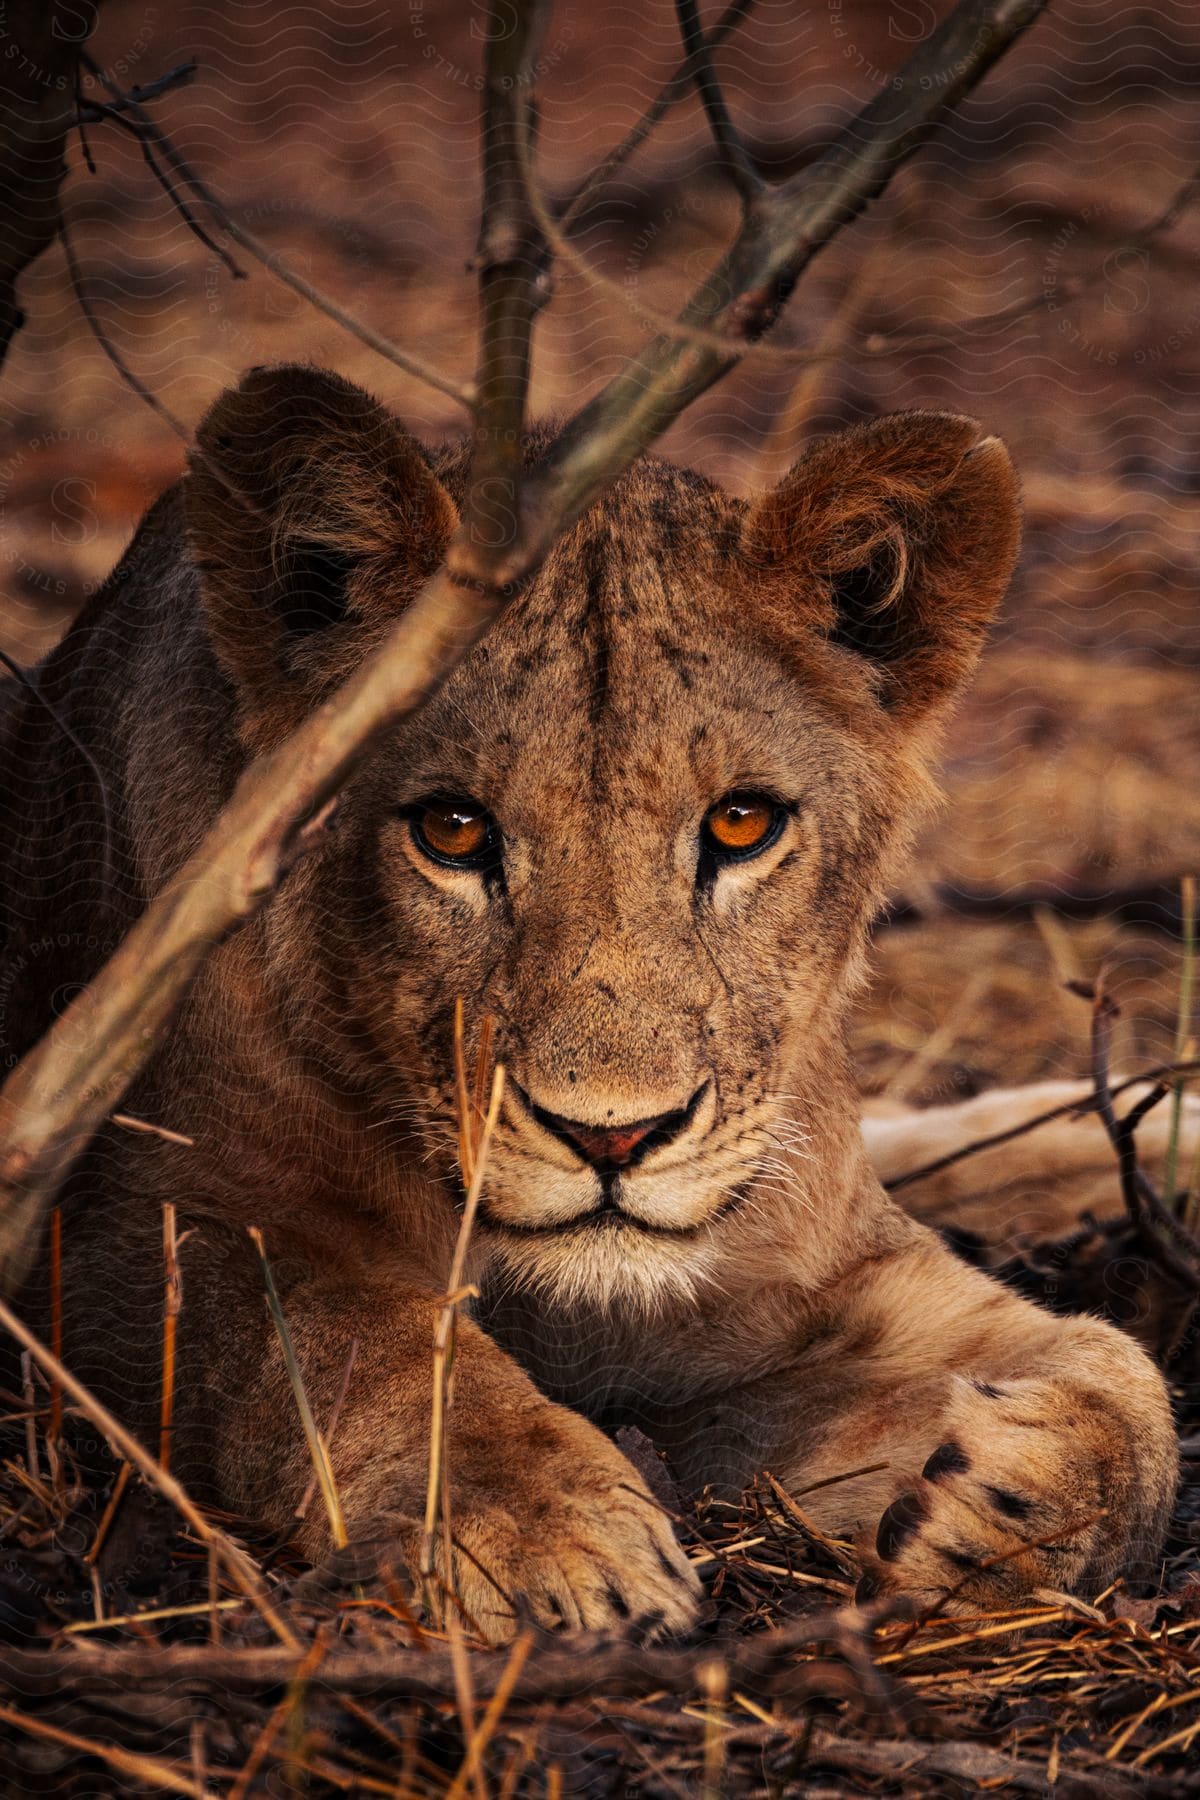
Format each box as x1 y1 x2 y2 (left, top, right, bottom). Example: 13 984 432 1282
743 412 1020 722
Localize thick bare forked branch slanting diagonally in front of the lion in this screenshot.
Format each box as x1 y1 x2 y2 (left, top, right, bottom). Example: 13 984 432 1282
0 0 1045 1280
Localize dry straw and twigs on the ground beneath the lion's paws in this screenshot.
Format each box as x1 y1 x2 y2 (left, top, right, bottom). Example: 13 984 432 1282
0 1389 1200 1800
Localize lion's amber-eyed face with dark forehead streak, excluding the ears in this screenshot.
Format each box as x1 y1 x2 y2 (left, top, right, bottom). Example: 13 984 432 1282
347 486 887 1303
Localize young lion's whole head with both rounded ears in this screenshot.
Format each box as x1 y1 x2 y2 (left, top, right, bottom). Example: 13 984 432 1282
187 369 1018 1296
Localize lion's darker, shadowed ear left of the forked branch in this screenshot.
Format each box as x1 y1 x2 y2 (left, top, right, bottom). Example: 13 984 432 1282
185 365 457 738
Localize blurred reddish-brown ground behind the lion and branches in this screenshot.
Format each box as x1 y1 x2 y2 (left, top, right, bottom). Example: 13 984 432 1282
0 0 1200 1103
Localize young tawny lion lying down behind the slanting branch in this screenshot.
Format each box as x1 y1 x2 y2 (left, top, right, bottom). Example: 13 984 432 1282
5 367 1177 1636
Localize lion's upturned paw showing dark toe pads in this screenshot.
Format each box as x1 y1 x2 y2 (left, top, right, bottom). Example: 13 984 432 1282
858 1379 1112 1613
